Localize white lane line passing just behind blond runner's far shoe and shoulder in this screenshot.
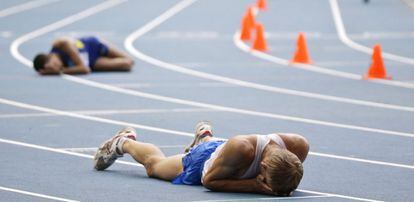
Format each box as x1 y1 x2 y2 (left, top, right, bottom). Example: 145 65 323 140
0 98 414 169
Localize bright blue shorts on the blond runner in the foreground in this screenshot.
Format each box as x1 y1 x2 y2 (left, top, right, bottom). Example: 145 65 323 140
172 140 225 185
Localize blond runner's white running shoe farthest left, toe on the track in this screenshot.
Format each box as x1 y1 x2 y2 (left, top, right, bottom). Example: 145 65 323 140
94 127 137 170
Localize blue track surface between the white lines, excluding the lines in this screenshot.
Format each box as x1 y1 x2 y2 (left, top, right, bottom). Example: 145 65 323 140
0 0 414 201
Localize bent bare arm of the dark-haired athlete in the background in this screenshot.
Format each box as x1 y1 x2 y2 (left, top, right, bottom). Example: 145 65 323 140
53 38 90 74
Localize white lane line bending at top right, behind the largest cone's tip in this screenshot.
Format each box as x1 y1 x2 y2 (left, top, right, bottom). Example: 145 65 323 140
329 0 414 65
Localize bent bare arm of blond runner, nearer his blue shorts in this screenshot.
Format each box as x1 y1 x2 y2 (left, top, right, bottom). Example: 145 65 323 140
203 136 274 194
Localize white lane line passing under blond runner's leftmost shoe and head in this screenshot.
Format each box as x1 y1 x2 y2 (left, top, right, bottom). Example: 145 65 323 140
0 138 382 201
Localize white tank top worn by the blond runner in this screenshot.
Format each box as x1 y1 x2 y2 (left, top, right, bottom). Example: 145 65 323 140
201 134 286 182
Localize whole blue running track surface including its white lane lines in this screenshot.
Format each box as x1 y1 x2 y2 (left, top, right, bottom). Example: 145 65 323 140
0 0 414 201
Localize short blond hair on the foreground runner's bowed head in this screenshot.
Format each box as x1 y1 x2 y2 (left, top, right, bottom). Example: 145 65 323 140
266 149 303 196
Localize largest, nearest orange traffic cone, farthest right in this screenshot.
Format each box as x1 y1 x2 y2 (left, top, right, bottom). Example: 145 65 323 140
364 44 391 79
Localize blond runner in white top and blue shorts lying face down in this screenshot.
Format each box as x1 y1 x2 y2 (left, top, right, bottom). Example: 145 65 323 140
94 122 309 196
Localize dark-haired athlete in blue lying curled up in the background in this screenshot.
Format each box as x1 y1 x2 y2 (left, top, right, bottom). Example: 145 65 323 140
33 37 134 75
